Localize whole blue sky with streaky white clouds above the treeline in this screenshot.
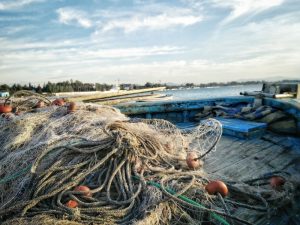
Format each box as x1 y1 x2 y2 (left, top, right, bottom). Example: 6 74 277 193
0 0 300 84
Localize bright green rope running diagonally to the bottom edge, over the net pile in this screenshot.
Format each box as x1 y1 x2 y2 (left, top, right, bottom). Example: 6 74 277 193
133 176 230 225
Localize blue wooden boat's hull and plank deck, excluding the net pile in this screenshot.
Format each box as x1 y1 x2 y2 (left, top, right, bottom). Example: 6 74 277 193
116 84 300 225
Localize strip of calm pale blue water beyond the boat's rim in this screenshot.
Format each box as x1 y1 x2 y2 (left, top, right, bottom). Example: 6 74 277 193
160 84 262 100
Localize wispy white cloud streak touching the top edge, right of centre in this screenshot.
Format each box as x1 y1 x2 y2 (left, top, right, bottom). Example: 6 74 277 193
212 0 285 24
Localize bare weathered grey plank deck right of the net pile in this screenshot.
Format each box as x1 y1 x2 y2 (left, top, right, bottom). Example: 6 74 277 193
204 135 297 177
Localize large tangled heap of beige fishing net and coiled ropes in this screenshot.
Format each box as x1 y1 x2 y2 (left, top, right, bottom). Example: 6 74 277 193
0 93 294 225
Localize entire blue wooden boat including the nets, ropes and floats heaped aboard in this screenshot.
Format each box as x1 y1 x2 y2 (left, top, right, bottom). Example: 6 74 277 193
0 85 300 225
